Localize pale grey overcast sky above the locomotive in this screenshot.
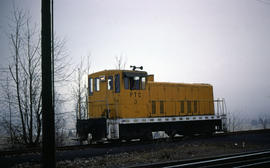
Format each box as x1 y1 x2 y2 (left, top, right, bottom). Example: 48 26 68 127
0 0 270 117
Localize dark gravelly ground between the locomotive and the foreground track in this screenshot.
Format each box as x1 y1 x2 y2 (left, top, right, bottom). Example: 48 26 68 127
2 130 270 168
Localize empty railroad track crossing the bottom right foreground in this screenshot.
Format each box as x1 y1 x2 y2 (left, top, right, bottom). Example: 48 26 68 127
129 150 270 168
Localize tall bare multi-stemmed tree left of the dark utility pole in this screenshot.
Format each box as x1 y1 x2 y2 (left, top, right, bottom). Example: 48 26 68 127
6 10 41 145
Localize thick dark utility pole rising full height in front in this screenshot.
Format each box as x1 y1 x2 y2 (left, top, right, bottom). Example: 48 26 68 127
41 0 56 168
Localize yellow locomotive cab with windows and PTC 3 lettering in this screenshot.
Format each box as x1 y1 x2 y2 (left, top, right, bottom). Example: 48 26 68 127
88 70 147 119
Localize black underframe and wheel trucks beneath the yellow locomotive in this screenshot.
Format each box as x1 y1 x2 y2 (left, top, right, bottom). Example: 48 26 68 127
76 118 222 140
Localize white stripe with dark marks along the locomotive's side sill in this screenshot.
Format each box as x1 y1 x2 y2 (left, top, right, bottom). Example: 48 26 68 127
106 115 226 124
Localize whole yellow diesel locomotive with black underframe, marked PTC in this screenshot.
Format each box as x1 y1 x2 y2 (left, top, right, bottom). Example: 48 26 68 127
76 68 226 141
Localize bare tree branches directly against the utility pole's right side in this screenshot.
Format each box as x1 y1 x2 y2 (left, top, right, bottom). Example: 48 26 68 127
53 36 74 146
